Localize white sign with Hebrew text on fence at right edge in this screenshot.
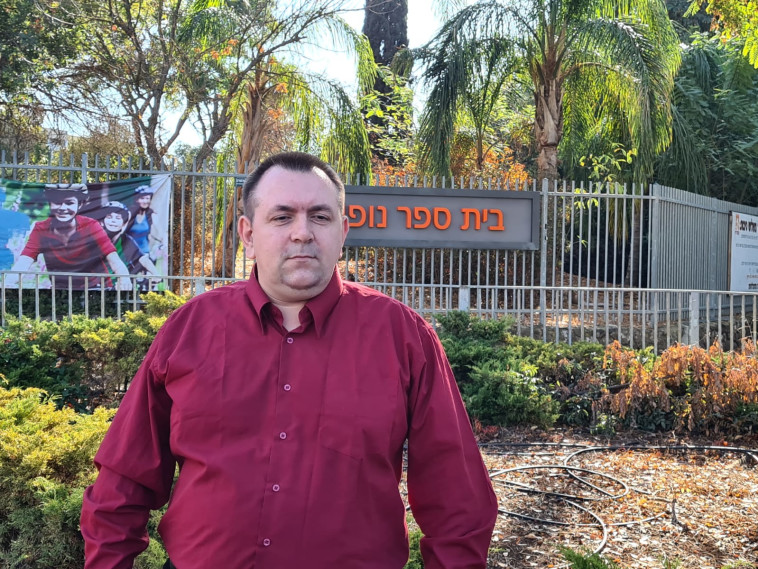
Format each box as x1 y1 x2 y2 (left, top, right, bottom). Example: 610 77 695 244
729 211 758 292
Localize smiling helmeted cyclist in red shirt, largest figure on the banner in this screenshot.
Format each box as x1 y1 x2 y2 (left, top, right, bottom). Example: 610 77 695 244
11 184 131 290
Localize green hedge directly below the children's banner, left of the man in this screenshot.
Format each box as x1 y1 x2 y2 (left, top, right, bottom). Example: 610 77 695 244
0 292 185 410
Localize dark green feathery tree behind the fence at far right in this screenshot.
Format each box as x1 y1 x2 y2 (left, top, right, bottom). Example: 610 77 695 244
656 34 758 205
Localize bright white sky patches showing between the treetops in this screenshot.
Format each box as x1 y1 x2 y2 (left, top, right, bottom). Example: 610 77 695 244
178 0 441 146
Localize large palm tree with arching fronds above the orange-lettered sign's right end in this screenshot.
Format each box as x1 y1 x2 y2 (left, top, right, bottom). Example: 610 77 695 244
420 0 680 180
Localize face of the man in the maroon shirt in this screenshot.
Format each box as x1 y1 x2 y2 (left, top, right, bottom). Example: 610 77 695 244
239 166 348 304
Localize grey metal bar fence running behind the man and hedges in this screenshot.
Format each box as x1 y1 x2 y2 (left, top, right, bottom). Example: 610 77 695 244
0 151 758 351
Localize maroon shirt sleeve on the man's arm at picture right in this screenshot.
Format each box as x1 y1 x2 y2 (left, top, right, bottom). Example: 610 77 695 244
408 322 497 569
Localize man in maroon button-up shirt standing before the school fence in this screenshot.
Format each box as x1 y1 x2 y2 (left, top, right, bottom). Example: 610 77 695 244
81 149 497 569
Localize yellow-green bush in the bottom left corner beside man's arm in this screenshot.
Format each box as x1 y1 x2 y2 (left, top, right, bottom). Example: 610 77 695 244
0 388 113 569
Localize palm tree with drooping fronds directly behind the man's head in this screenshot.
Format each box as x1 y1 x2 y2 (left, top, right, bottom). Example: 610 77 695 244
181 0 376 276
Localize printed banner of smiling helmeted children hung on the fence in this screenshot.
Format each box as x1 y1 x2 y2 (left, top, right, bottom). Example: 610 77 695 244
0 174 172 291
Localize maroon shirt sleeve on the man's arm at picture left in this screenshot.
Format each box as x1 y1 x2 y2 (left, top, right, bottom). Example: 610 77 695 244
81 325 176 569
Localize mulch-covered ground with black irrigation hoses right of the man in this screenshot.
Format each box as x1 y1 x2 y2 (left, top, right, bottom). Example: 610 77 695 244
481 429 758 569
